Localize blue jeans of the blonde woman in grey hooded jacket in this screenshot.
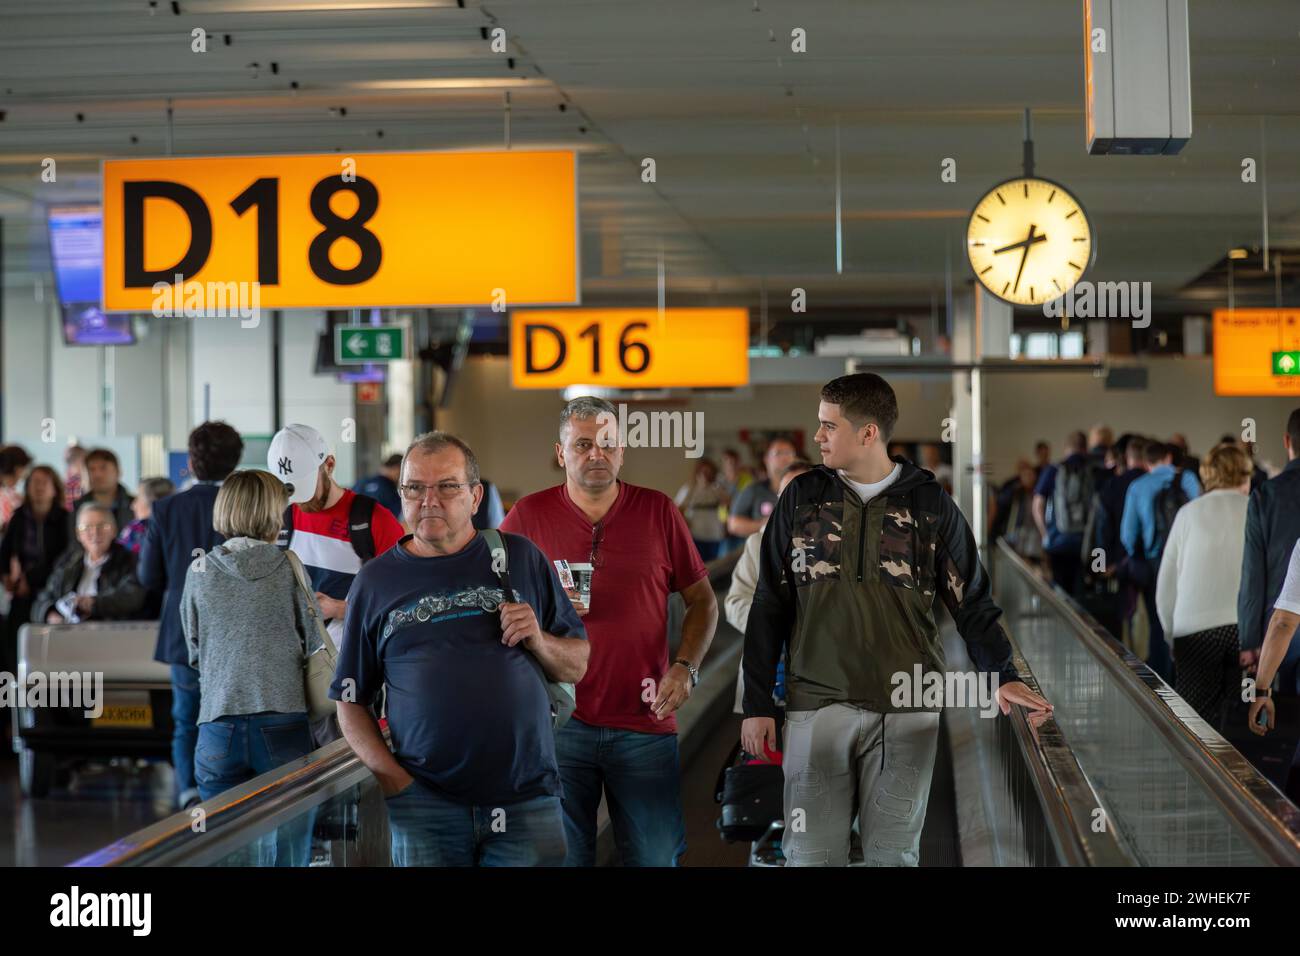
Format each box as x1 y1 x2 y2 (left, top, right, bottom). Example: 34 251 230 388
194 713 316 866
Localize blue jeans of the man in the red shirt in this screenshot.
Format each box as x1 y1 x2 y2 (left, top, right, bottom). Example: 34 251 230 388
555 719 686 866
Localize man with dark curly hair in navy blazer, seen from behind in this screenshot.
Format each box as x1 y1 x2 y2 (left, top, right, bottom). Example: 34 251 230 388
138 421 243 809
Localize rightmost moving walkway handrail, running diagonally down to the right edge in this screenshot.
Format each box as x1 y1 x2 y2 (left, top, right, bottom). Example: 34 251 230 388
997 538 1300 866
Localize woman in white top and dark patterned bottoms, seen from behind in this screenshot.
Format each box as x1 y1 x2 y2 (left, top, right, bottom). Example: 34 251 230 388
1156 445 1252 730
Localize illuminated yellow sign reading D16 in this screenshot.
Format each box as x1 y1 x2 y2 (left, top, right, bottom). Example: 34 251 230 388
510 308 749 389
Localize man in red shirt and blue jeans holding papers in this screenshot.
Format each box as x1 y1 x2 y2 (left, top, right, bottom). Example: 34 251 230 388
501 397 718 866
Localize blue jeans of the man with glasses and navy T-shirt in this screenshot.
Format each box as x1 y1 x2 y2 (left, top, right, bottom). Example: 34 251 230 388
385 780 564 866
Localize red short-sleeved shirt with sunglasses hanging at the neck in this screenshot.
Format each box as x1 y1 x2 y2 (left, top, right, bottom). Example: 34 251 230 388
501 481 709 734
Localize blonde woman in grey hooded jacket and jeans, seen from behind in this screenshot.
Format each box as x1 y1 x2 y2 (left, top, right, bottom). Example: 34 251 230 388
181 471 320 866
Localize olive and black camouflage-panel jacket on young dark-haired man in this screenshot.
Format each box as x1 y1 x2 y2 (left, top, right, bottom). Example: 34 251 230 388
744 458 1018 717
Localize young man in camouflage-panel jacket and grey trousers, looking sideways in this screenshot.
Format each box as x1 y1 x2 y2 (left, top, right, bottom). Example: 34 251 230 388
741 372 1050 866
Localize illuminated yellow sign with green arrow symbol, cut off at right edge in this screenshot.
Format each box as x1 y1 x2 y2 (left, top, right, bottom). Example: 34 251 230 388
1214 308 1300 395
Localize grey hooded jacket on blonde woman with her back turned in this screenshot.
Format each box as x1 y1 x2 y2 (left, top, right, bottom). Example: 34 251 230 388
181 537 321 723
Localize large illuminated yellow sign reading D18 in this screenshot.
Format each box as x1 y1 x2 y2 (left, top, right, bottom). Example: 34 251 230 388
103 150 580 312
